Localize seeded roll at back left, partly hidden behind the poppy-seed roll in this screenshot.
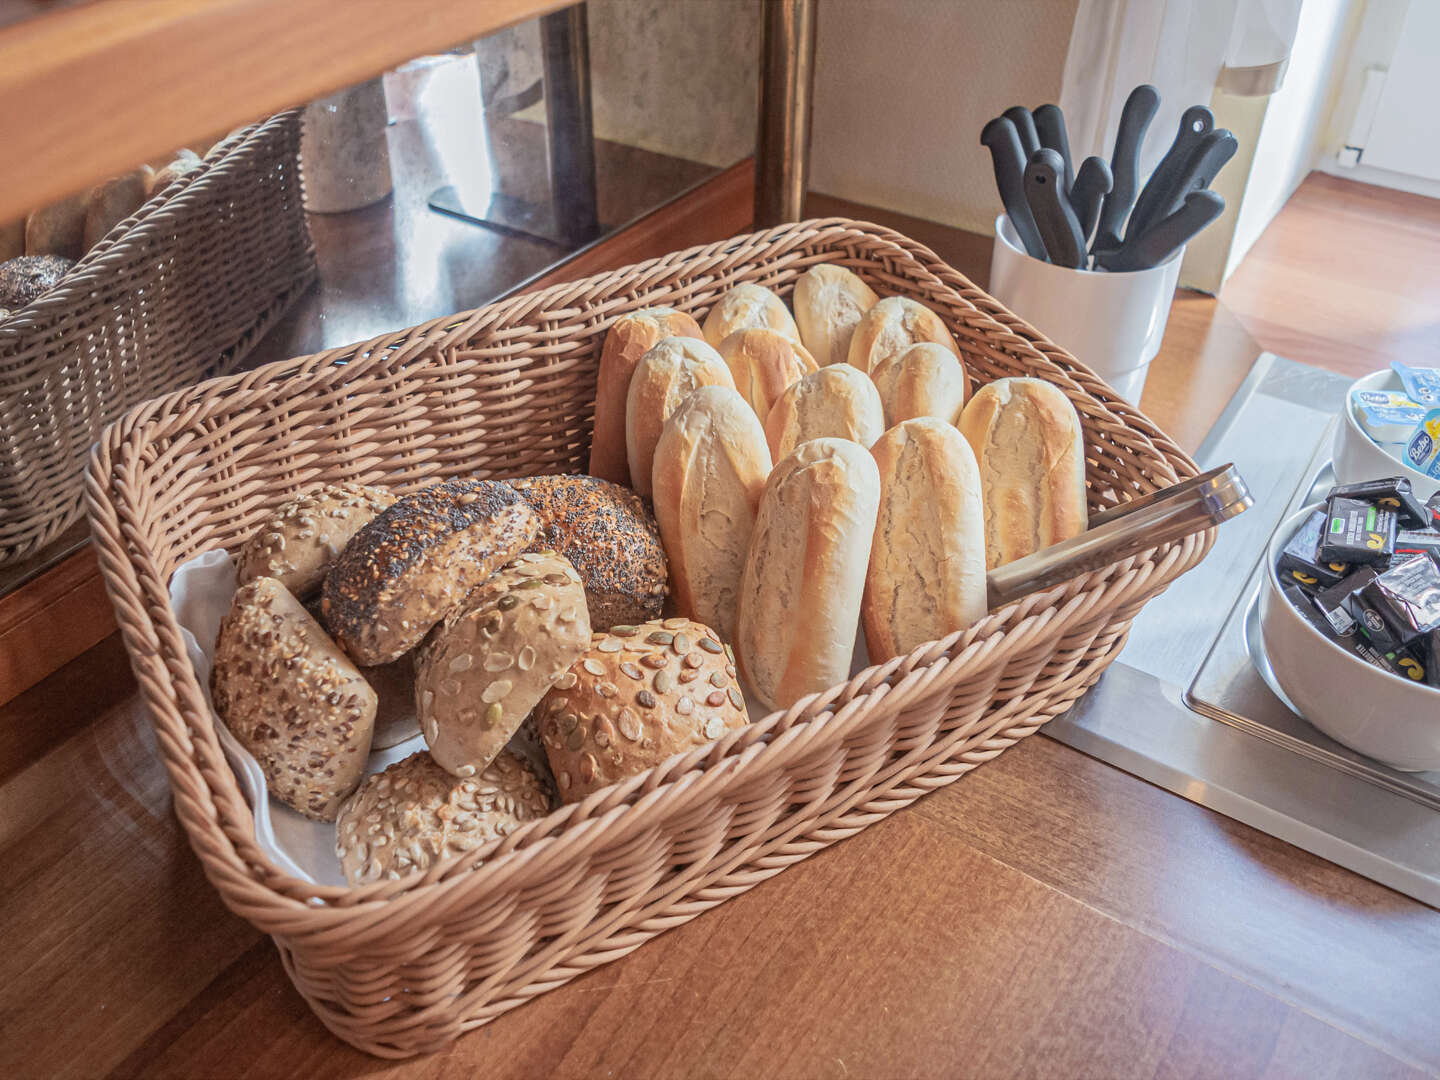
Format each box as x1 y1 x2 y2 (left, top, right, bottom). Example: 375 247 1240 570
236 484 395 598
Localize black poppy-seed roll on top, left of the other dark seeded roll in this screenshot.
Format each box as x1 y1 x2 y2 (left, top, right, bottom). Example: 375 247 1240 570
320 480 540 665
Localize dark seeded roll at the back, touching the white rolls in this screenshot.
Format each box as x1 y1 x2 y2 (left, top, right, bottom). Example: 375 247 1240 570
510 477 670 631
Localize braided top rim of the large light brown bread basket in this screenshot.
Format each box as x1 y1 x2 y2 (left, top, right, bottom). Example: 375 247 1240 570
78 217 1214 935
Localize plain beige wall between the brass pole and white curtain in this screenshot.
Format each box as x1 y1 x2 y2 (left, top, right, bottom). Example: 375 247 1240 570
809 0 1077 233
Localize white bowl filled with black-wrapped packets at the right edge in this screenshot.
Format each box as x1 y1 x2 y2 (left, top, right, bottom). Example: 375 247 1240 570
1260 506 1440 772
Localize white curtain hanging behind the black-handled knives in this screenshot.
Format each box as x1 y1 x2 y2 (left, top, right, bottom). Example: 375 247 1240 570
1060 0 1302 169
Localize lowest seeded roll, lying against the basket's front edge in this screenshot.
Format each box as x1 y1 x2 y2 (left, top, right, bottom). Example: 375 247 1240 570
336 750 550 886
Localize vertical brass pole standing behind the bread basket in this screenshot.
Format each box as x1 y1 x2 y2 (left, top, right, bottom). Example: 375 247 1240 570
755 0 815 229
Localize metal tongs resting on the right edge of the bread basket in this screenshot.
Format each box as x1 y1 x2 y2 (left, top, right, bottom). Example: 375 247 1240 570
985 464 1254 611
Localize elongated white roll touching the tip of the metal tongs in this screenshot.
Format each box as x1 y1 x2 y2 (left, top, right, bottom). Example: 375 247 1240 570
861 416 988 664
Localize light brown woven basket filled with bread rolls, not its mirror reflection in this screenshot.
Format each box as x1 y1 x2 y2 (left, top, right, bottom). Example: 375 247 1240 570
88 219 1214 1057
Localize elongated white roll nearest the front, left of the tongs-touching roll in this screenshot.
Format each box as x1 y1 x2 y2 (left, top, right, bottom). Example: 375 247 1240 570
736 439 880 708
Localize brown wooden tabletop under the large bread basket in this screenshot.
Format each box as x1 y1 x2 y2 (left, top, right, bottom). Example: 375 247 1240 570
0 203 1440 1080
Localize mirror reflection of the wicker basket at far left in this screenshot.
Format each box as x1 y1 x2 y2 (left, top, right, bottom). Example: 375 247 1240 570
0 111 315 564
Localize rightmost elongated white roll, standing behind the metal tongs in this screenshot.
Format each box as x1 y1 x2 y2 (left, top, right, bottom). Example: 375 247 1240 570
960 379 1087 570
